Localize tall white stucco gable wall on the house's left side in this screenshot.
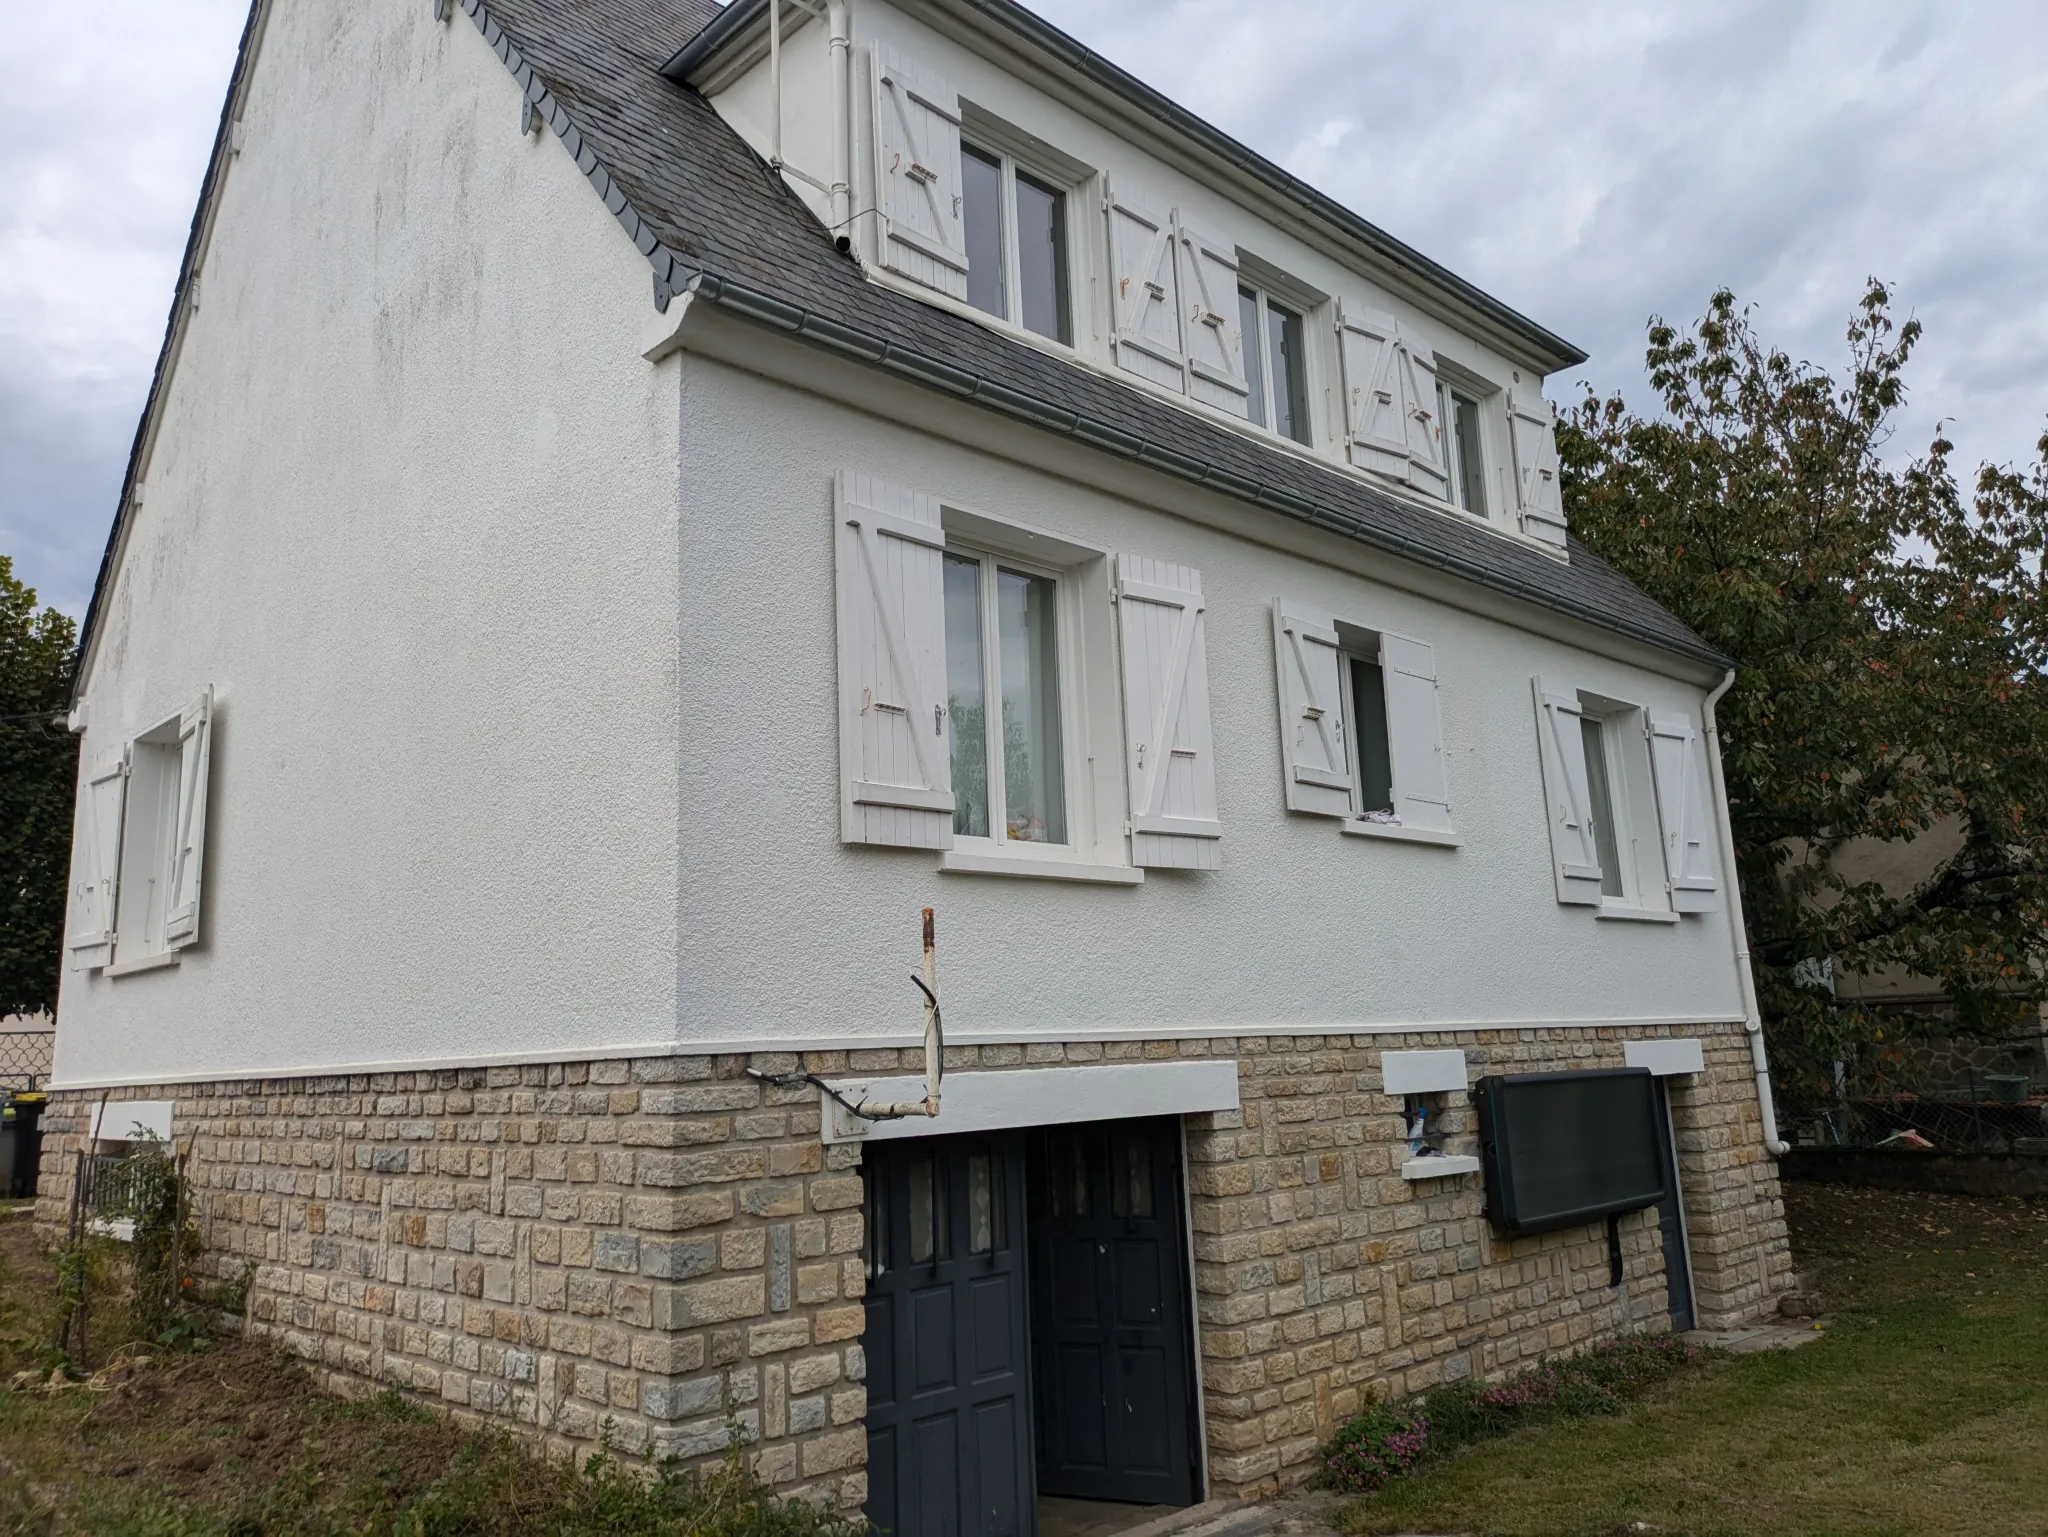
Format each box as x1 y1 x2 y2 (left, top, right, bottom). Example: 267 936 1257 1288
57 0 678 1082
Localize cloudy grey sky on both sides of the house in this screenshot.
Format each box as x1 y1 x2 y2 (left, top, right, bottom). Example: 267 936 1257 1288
0 0 2048 615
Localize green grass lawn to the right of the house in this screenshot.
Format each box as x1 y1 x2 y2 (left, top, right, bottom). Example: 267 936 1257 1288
1339 1185 2048 1537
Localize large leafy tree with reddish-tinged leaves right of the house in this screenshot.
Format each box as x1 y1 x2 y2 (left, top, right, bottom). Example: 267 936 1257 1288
1559 281 2048 1096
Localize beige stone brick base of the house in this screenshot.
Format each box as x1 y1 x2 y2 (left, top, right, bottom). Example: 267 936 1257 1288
39 1027 1790 1506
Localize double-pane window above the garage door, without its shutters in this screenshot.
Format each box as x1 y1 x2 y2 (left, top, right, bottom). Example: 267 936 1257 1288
946 543 1073 848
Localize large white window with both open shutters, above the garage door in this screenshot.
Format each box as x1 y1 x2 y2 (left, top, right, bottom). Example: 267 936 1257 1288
834 471 1223 885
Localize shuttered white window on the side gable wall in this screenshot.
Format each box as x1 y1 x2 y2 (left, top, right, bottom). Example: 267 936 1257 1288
70 689 213 973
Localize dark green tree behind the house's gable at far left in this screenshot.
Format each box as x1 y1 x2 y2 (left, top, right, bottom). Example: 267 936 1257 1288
0 555 78 1016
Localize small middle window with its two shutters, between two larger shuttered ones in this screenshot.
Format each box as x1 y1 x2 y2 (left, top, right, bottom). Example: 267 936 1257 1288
1274 600 1458 846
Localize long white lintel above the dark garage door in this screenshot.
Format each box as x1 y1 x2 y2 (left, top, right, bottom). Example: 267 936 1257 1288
819 1057 1237 1141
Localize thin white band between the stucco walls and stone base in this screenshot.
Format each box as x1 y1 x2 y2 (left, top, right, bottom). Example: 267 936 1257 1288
47 1014 1743 1094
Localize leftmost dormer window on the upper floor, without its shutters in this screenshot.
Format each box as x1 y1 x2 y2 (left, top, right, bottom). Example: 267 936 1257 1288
961 143 1073 344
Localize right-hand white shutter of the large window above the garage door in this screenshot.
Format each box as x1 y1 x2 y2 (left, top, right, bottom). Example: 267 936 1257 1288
1116 555 1223 869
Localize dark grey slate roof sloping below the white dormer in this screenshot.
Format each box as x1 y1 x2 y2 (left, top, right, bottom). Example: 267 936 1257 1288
80 0 1729 684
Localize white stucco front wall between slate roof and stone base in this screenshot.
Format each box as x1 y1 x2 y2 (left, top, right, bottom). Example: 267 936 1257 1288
659 340 1741 1043
